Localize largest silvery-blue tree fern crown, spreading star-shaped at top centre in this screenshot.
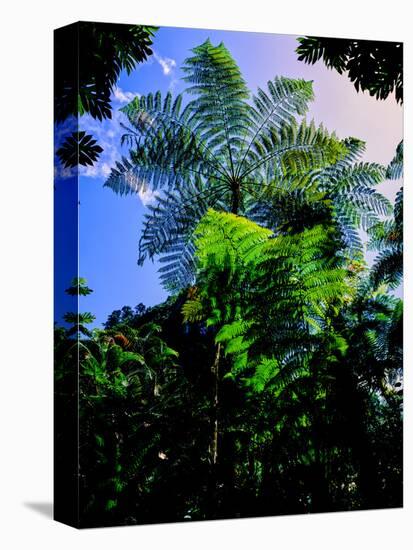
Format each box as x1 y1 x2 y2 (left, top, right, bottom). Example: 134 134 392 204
105 40 358 288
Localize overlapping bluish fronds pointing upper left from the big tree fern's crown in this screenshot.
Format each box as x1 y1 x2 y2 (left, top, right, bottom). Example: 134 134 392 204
105 93 222 199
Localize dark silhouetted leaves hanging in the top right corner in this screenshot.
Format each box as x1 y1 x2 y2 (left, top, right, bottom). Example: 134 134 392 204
297 36 403 103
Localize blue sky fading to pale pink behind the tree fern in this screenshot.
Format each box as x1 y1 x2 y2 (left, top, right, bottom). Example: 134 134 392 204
55 28 403 326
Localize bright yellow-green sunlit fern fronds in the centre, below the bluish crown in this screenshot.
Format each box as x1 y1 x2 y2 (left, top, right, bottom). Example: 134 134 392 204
187 210 349 394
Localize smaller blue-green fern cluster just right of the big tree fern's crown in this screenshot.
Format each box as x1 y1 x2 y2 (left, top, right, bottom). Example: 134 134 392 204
247 138 392 259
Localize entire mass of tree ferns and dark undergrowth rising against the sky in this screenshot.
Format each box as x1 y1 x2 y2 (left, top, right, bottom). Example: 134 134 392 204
56 41 403 526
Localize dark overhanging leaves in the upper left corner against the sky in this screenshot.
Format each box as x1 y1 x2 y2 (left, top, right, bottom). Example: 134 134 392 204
54 21 157 167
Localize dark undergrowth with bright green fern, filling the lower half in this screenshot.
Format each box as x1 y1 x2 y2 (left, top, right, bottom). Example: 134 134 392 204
56 264 402 526
